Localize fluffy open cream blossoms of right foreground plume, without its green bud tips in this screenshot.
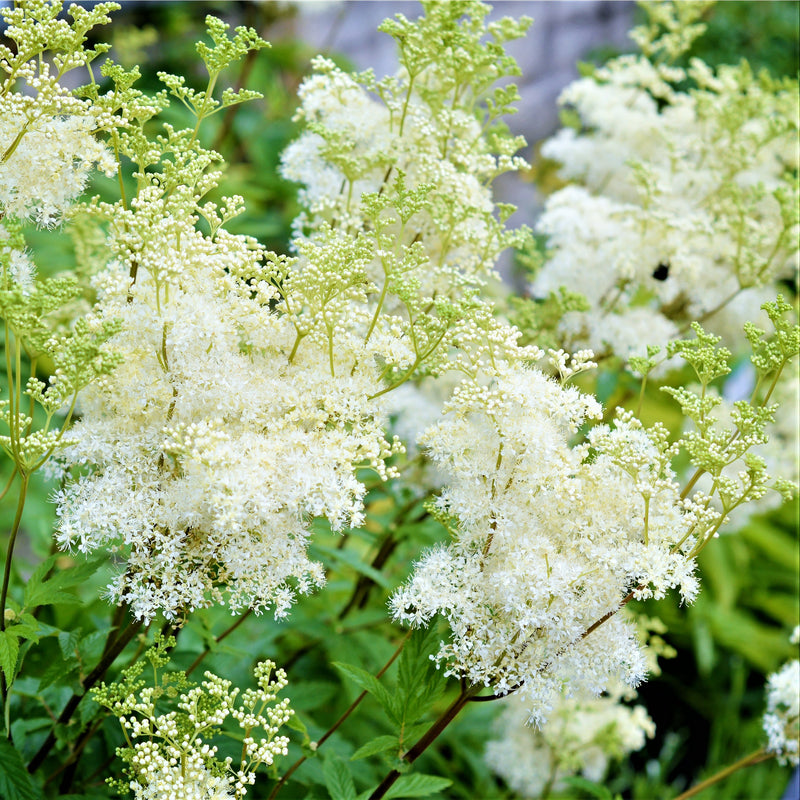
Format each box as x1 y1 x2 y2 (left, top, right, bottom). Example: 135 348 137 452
391 366 703 720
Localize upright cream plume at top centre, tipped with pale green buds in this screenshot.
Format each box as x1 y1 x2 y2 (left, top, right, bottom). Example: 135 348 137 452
282 2 530 386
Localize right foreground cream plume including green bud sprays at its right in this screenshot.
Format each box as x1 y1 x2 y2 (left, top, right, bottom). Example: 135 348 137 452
391 296 800 723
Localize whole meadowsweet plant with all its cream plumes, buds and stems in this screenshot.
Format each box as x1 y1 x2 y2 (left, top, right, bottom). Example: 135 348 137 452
0 0 800 800
